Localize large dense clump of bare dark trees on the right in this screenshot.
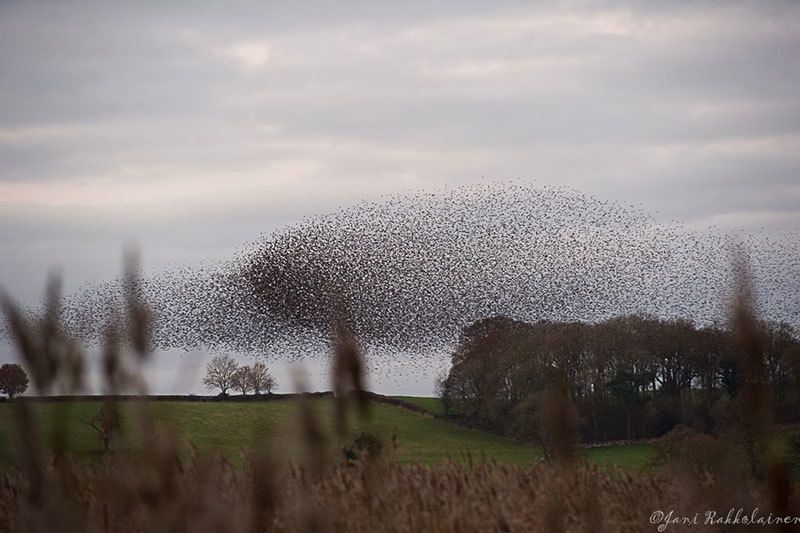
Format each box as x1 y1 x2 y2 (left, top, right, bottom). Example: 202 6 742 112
440 316 800 442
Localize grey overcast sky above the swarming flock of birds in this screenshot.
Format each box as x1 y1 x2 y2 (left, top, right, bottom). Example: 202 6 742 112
0 1 800 394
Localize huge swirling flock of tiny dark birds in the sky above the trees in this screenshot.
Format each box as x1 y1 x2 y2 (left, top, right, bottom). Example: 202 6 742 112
51 184 800 378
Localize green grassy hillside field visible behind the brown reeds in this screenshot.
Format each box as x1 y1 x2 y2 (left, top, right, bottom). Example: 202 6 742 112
0 398 649 467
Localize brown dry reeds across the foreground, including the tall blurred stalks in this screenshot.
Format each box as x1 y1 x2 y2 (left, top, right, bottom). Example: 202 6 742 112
0 261 797 533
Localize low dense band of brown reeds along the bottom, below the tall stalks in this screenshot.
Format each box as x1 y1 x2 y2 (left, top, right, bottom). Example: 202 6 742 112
0 445 770 532
